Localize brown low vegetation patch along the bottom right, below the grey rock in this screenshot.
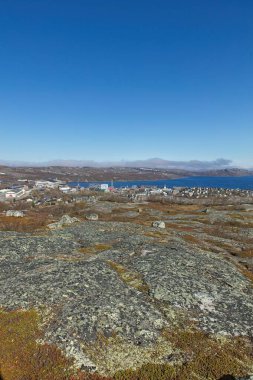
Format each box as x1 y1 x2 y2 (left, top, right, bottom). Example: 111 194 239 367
114 329 252 380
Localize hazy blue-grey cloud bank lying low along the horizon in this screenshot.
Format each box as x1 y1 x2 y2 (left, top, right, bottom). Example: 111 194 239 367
0 158 253 171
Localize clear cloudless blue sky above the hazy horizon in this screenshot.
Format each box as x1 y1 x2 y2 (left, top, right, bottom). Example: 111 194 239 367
0 0 253 166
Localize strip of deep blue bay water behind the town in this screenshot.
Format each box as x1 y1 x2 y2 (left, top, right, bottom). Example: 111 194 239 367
69 176 253 190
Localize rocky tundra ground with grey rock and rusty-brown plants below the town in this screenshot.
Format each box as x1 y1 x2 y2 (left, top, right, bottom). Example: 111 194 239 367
0 194 253 380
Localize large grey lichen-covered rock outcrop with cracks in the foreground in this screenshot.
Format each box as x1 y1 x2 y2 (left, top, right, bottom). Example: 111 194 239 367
0 221 253 367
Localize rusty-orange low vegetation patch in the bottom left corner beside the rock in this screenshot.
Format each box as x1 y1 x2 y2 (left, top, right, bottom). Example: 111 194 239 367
0 310 109 380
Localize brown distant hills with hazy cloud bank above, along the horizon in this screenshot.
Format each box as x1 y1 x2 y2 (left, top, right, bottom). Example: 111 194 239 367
0 158 253 184
